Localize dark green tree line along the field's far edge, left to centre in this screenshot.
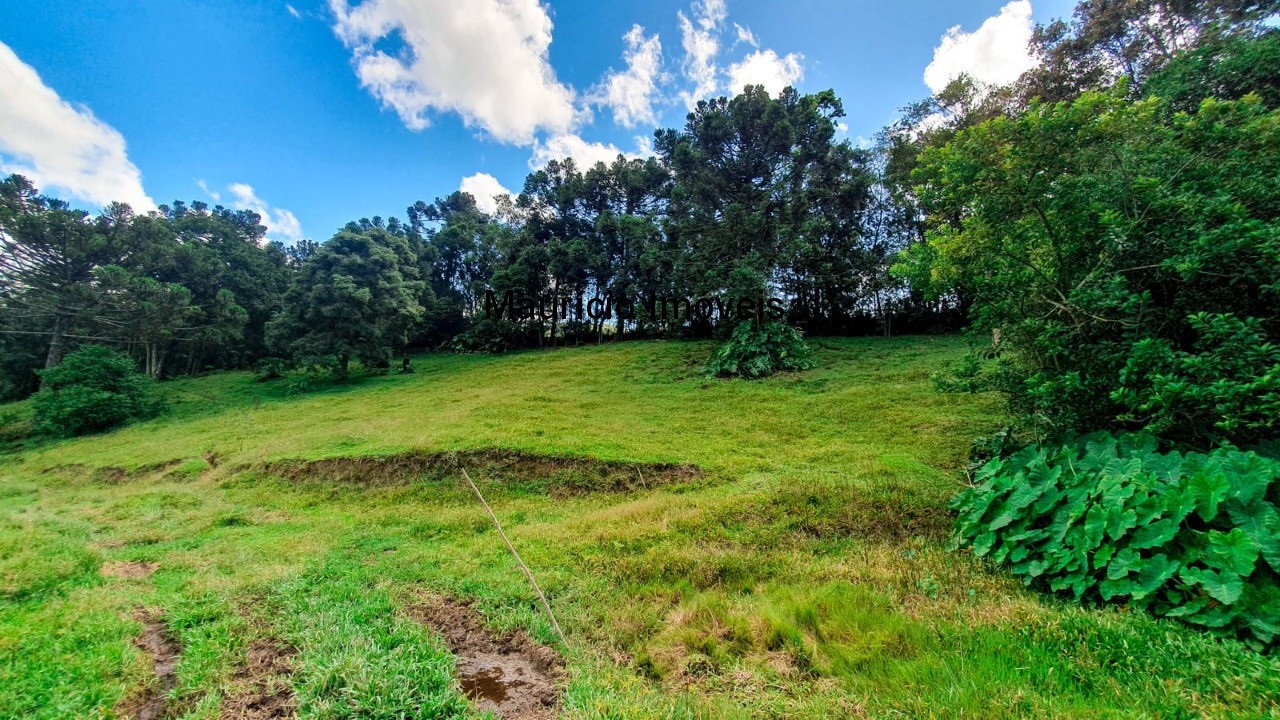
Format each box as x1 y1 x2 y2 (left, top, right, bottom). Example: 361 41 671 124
0 87 956 397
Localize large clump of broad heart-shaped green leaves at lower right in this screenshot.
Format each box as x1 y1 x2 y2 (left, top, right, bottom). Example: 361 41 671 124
951 434 1280 648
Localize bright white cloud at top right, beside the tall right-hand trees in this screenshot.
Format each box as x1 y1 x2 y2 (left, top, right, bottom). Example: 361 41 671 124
924 0 1034 92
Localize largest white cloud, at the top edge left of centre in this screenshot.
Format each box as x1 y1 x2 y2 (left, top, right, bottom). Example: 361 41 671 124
330 0 576 145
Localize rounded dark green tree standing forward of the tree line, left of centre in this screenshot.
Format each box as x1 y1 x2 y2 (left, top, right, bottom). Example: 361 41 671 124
268 227 424 379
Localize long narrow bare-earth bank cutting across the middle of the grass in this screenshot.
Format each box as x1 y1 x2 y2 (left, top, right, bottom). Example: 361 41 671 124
257 450 703 495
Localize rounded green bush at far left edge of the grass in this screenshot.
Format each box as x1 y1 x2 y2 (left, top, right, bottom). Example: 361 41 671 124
32 345 161 437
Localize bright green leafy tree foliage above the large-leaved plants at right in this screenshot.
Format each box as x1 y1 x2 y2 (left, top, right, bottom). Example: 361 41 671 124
897 92 1280 446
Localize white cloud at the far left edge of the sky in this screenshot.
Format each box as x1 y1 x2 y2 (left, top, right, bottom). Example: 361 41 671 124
0 42 156 211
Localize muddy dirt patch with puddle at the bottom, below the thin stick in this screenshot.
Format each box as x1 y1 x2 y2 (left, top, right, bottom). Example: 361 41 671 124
410 597 564 720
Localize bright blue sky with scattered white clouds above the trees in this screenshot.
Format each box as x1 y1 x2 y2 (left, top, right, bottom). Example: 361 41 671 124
0 0 1073 242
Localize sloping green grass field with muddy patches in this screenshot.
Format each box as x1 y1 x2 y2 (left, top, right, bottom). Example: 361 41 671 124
0 337 1280 719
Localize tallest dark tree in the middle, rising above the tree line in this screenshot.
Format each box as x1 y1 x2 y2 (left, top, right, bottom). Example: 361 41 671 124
655 86 859 327
